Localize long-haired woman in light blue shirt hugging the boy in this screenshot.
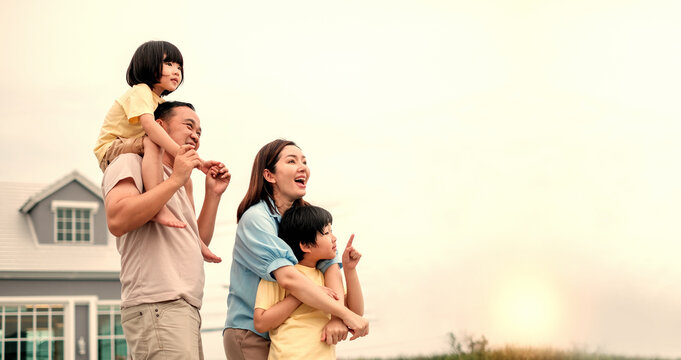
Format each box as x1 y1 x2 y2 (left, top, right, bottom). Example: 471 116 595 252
223 139 369 360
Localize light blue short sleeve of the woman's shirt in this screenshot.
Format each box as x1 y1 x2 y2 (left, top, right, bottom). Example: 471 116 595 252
234 204 298 281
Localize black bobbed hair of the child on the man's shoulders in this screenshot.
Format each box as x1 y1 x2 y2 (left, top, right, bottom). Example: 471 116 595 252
125 40 184 96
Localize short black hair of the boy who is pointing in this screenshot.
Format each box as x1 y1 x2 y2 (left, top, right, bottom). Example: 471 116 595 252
279 205 333 261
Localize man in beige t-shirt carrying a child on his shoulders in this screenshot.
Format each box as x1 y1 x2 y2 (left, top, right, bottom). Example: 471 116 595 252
102 102 231 359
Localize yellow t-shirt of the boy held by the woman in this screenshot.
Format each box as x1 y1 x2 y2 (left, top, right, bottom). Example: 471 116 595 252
255 264 336 360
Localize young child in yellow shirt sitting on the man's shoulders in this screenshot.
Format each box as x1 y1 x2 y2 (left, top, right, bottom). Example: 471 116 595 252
94 41 226 262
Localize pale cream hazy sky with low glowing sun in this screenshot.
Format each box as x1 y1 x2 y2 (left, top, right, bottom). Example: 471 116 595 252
0 0 681 359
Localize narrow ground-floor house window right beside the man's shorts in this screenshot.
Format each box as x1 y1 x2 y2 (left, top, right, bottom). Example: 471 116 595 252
97 305 128 360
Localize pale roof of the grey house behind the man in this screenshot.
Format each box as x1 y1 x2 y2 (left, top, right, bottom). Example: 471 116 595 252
0 171 120 279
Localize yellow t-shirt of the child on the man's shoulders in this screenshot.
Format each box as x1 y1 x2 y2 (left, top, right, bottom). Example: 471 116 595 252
94 84 164 162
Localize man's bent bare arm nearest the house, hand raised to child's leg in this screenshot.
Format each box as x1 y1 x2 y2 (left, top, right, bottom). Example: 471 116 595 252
104 145 199 236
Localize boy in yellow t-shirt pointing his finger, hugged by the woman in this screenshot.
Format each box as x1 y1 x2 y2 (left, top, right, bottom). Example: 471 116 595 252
253 206 364 360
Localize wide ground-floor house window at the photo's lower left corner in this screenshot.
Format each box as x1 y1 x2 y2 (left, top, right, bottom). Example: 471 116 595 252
0 304 64 360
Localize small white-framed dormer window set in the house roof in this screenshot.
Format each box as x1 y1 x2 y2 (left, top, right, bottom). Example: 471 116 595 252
52 201 99 243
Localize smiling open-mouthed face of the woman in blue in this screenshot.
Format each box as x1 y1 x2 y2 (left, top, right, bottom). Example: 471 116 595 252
265 145 310 201
